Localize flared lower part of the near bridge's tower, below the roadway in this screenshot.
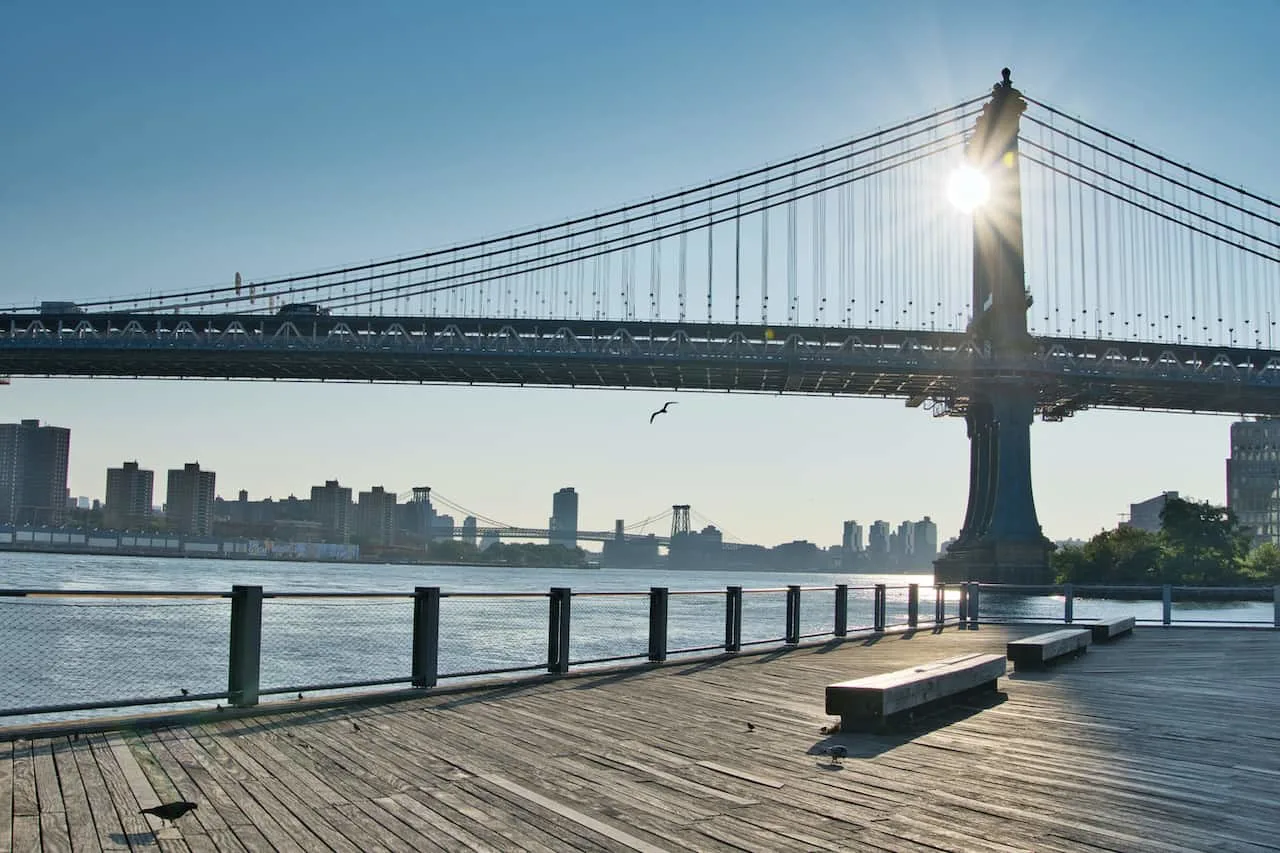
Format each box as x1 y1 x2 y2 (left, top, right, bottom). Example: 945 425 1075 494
933 387 1055 584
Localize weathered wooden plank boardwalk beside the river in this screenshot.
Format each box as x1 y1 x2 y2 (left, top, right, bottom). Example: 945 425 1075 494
0 626 1280 853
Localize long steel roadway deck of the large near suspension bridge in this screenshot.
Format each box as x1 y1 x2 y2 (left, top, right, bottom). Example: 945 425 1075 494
0 313 1280 419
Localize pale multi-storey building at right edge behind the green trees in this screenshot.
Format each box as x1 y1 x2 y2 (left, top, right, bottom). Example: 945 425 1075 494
1226 418 1280 544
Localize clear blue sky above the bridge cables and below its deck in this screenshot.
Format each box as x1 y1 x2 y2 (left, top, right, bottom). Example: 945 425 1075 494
0 0 1280 544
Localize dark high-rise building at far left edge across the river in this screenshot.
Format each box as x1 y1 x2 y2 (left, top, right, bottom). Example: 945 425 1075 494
0 419 72 526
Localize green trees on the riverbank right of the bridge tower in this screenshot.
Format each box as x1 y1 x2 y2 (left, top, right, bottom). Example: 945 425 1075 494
1052 498 1264 585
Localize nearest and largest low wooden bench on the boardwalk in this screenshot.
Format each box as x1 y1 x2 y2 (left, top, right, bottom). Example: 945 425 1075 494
827 654 1006 731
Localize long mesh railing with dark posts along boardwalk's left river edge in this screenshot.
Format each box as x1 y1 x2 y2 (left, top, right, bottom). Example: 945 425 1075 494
0 584 942 720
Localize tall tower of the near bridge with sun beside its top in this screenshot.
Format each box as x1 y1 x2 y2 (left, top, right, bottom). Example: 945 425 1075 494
933 68 1055 584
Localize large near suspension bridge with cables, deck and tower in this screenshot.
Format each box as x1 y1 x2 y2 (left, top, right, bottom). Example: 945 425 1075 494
0 69 1280 581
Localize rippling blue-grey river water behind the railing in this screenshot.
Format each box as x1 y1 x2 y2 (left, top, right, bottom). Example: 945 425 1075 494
0 552 1274 726
